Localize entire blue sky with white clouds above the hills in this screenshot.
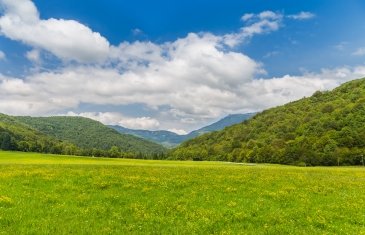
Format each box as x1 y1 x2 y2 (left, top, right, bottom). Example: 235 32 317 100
0 0 365 134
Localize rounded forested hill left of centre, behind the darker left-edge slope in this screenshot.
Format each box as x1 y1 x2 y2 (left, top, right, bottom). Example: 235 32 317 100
15 117 165 154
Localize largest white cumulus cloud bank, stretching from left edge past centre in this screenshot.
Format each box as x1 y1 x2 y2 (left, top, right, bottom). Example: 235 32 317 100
0 34 262 117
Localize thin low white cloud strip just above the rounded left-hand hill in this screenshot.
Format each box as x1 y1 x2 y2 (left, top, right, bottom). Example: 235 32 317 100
66 112 160 130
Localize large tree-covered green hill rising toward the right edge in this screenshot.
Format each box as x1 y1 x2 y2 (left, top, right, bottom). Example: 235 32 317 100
171 78 365 165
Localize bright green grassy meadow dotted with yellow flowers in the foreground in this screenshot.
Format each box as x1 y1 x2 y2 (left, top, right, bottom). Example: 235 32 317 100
0 152 365 234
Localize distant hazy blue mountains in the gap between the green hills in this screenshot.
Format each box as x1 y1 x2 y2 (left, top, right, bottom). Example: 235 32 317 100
110 113 254 147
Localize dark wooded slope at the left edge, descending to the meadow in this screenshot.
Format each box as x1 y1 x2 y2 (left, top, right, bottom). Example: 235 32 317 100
0 114 78 154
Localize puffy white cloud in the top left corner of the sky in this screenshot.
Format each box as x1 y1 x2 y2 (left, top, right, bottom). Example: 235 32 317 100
0 0 109 63
